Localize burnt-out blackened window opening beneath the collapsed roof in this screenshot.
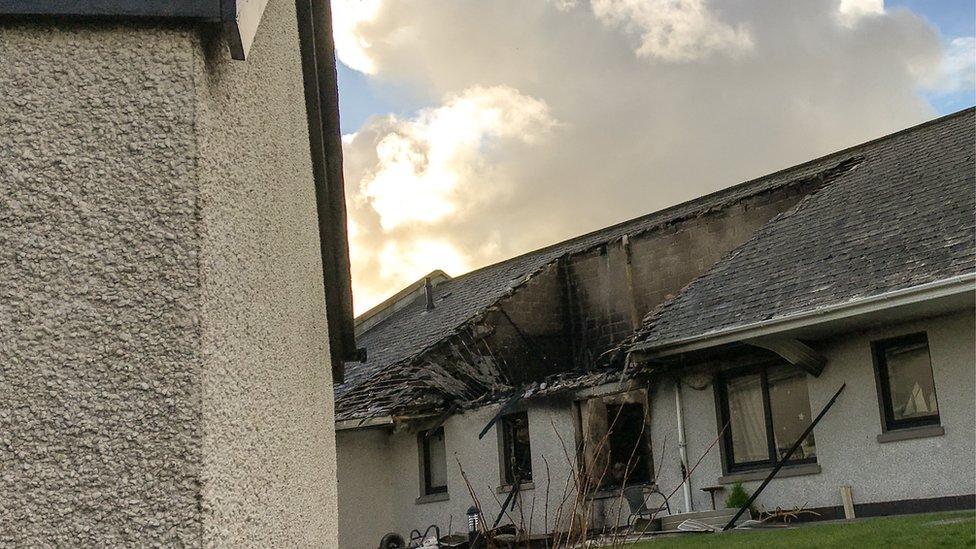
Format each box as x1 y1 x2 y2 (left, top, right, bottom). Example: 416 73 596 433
579 390 654 489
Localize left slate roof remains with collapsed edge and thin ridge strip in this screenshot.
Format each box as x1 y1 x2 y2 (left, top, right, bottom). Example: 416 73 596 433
335 111 972 420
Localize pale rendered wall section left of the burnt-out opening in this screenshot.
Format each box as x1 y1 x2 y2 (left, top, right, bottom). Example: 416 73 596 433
337 402 575 548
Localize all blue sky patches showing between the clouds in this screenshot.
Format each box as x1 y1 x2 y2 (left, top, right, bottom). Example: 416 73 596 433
338 0 976 134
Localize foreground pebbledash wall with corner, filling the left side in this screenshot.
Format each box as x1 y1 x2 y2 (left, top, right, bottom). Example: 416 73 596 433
0 1 337 547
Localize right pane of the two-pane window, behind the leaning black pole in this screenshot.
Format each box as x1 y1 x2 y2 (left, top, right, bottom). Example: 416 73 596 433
766 365 817 460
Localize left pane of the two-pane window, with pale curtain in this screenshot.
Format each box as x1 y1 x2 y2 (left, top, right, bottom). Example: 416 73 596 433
726 374 769 463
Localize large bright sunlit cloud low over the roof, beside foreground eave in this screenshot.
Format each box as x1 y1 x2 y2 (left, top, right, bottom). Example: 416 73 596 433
343 86 556 310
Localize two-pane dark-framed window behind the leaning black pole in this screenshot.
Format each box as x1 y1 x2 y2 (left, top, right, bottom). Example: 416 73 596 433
717 363 817 471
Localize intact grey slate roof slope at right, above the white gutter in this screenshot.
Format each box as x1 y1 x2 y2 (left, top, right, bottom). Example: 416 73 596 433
635 109 976 348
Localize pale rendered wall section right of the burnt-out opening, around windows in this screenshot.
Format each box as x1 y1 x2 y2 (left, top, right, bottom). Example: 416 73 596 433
652 310 976 510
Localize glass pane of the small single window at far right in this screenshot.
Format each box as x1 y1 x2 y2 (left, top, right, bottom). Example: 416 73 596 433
882 338 939 421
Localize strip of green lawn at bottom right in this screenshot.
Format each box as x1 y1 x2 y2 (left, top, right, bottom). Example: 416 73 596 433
630 511 976 549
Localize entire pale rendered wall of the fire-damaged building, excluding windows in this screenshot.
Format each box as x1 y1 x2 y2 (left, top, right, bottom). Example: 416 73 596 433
338 311 976 548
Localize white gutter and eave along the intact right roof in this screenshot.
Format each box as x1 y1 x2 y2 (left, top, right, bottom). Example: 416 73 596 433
628 273 976 361
